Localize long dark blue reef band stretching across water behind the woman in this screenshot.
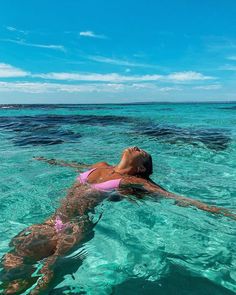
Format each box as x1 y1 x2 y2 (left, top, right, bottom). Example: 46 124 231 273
0 114 231 151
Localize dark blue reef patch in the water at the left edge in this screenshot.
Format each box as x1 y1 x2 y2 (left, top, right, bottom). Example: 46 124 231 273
0 115 134 146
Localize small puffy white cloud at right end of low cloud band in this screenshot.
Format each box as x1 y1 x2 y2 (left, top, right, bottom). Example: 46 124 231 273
167 71 215 82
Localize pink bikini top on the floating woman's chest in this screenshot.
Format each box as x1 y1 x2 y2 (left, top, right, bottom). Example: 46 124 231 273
77 168 121 192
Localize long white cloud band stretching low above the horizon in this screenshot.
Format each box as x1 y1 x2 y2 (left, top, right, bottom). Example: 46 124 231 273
0 63 217 97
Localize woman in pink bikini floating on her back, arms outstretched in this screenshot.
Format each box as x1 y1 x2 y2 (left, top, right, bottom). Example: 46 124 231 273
1 147 236 294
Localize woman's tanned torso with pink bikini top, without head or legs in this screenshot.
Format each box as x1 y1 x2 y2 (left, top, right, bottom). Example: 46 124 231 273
56 163 148 222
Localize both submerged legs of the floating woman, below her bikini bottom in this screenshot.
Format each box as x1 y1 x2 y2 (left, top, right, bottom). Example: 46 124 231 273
1 215 95 295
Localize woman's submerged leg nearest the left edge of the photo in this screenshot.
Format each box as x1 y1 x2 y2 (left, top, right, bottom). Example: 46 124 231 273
1 224 57 294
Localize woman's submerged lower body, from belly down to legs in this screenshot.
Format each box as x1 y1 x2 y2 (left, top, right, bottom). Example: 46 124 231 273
1 183 107 294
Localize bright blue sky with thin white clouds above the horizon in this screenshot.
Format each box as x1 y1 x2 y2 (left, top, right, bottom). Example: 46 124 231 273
0 0 236 104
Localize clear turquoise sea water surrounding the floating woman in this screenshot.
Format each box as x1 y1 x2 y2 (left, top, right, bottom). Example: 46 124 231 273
0 104 236 295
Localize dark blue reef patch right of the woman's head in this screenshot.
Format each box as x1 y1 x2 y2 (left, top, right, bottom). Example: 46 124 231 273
138 125 231 151
